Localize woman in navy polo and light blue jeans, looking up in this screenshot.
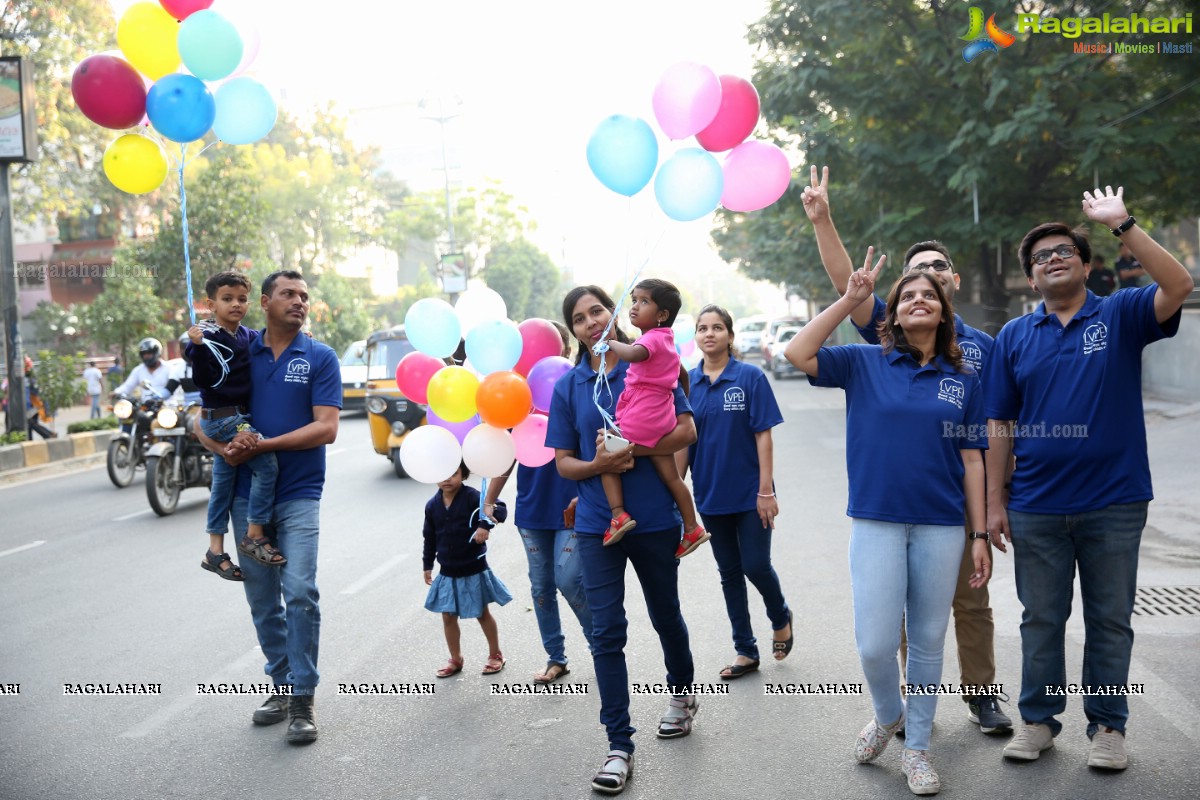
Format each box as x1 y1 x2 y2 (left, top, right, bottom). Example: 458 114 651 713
785 248 991 794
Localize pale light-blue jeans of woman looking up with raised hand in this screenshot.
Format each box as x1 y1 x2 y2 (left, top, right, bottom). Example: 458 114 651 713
850 519 966 750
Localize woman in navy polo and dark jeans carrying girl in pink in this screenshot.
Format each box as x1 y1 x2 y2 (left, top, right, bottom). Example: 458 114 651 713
546 285 698 794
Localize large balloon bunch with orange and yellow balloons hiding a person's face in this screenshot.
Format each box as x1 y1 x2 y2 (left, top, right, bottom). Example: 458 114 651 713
396 288 571 483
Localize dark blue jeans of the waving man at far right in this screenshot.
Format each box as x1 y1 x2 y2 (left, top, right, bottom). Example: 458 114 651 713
1008 503 1148 736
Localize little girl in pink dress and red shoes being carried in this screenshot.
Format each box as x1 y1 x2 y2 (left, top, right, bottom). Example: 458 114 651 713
600 278 708 558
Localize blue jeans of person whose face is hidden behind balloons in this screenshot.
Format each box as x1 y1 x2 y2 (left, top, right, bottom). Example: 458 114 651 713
517 528 592 664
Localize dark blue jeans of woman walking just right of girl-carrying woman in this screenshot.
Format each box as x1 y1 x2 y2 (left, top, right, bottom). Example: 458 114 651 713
702 511 788 661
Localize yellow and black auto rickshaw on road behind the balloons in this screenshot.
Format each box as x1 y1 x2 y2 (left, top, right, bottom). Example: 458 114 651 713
365 325 426 477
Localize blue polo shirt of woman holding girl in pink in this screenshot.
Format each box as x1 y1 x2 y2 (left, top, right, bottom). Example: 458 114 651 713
546 359 691 536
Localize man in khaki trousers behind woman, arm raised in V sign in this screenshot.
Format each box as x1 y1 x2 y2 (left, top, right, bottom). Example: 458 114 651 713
800 166 1013 734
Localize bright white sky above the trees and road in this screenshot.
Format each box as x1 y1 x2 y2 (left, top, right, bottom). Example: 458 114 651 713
112 0 794 312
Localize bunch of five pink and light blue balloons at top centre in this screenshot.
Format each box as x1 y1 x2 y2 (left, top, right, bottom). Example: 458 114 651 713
587 61 792 222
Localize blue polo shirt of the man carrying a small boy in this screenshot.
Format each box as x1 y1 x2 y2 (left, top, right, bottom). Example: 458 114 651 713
238 332 342 503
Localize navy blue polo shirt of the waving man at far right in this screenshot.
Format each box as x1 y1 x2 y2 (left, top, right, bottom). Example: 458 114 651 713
985 284 1182 515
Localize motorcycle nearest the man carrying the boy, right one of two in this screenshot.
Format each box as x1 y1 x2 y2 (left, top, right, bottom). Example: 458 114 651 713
146 399 212 517
